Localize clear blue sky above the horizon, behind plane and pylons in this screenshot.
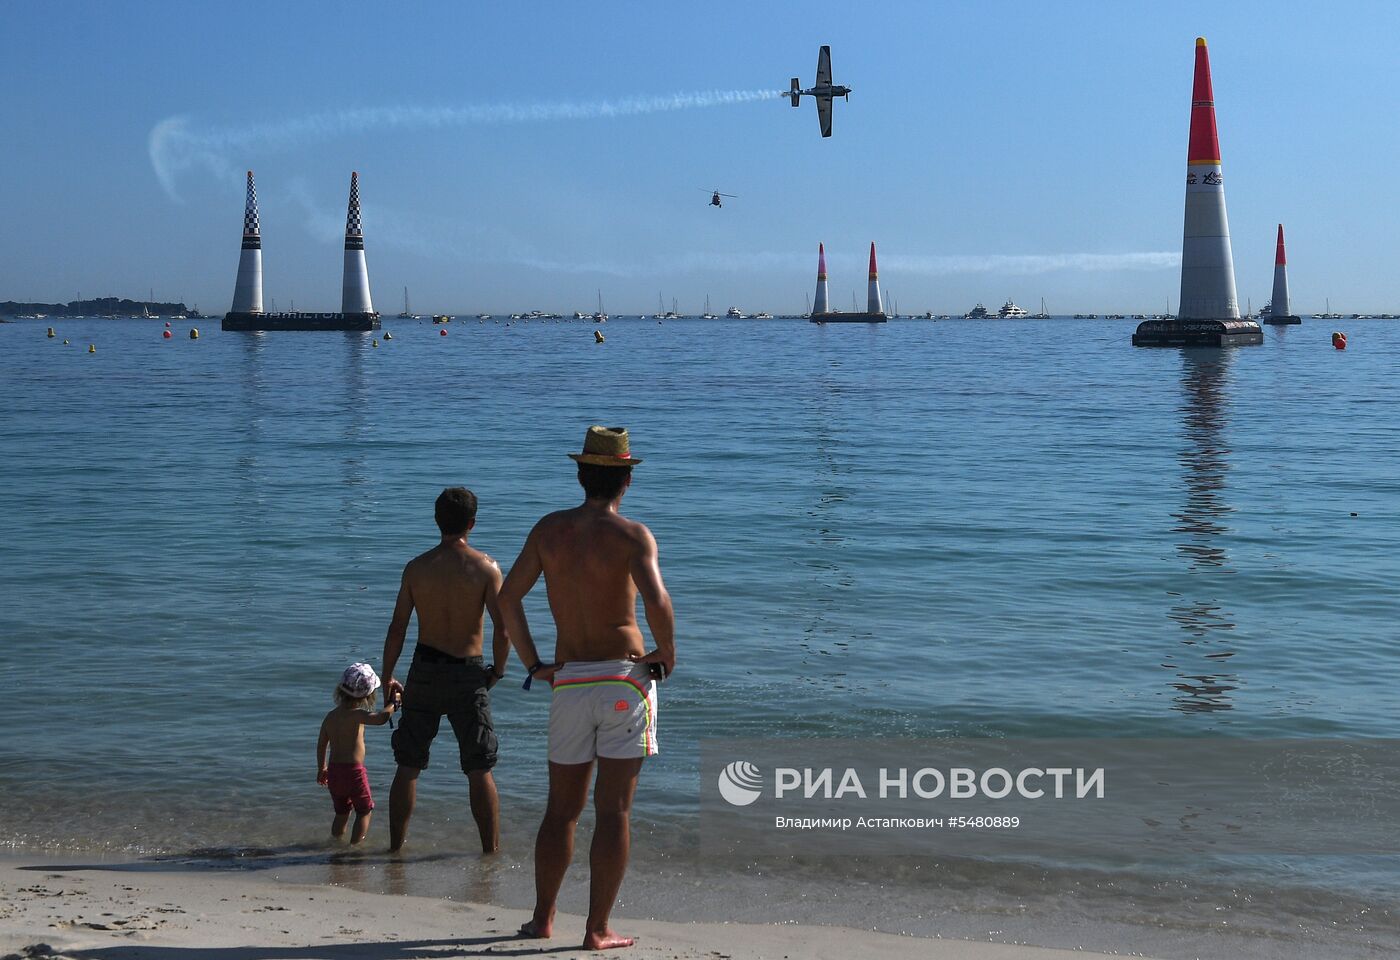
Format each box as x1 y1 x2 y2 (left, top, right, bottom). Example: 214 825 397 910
0 1 1400 312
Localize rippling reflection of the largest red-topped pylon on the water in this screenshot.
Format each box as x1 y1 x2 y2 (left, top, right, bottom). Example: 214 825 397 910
1162 350 1239 714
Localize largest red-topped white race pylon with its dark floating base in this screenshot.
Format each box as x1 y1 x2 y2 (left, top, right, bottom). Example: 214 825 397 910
1133 43 1264 347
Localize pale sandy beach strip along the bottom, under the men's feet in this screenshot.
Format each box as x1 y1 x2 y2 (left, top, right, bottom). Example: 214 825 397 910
0 859 1131 960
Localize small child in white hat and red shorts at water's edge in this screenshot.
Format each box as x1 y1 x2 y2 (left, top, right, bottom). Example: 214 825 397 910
316 663 398 844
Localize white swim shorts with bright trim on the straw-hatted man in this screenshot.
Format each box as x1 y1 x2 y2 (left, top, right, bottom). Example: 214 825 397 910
549 661 657 764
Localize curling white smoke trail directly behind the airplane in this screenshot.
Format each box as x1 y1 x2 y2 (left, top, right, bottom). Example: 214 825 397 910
156 90 785 200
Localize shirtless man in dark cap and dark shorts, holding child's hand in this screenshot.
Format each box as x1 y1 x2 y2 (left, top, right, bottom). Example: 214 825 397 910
384 487 510 854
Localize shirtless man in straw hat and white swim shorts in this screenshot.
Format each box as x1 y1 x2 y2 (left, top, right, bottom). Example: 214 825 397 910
500 427 676 950
